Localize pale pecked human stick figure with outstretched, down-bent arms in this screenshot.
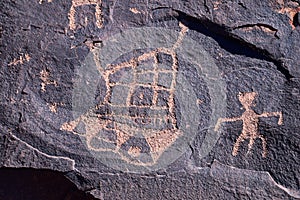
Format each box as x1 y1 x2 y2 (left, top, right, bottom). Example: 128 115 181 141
215 92 283 158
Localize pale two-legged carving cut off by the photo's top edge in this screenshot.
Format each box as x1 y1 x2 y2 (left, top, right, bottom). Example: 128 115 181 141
69 0 103 30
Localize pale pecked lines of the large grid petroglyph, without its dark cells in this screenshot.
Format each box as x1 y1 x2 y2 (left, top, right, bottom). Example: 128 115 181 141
62 21 192 166
